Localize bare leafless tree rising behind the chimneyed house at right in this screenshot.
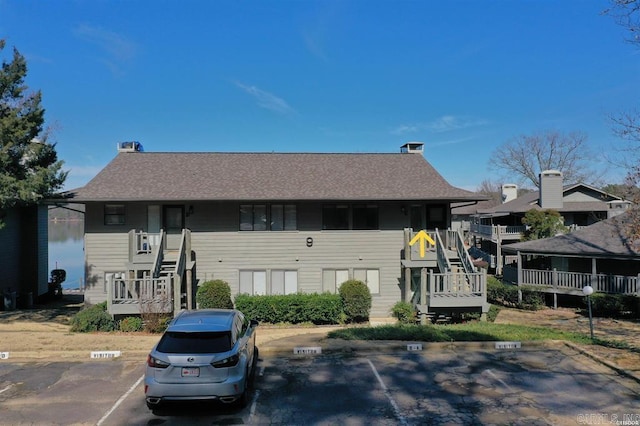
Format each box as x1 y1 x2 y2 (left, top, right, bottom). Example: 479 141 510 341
489 130 594 188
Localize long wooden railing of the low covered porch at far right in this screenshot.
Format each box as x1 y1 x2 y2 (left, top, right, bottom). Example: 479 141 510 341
503 266 640 295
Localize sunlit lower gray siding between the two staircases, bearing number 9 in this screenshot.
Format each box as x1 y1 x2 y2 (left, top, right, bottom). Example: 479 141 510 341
191 231 403 316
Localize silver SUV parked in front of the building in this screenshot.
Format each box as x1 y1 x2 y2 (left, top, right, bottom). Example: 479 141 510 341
144 309 258 410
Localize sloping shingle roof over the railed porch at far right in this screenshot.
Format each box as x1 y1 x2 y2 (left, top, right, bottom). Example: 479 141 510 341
502 211 640 260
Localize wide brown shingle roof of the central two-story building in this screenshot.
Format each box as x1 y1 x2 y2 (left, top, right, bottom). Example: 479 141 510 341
71 152 483 202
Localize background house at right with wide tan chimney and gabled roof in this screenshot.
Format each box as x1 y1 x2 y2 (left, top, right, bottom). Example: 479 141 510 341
469 170 631 275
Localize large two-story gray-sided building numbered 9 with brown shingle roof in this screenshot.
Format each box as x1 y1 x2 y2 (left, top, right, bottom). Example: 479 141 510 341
69 143 486 316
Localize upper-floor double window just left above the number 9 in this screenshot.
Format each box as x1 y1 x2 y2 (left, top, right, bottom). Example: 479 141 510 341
240 204 298 231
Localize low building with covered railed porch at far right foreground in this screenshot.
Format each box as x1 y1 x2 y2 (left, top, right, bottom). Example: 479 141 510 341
503 211 640 304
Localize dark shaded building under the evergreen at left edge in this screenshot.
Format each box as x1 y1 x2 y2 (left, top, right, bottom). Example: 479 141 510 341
0 205 49 309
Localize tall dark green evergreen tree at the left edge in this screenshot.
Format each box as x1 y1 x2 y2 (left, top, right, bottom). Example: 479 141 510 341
0 40 67 228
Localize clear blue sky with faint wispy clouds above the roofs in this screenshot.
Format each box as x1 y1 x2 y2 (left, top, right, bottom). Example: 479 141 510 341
0 0 640 190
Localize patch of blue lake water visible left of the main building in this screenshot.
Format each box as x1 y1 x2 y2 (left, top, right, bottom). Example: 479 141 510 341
49 220 84 290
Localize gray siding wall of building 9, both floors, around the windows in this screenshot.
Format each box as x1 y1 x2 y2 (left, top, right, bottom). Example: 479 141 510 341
85 202 430 316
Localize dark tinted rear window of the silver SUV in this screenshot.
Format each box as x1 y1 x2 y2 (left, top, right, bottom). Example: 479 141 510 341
157 331 231 354
